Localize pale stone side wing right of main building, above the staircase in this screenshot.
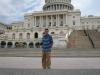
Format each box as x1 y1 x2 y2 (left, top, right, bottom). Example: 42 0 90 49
81 15 100 30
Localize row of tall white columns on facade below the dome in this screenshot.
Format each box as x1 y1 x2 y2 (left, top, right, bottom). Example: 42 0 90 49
32 14 67 27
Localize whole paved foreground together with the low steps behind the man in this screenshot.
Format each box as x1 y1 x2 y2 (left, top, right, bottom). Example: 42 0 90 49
0 48 100 75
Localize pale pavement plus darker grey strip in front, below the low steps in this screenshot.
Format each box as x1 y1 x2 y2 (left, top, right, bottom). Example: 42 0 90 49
0 57 100 75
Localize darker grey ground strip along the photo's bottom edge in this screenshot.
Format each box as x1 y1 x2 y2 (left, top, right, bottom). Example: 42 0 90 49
0 69 100 75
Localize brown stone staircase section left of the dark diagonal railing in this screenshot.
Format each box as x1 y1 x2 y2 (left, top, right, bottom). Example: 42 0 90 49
68 30 93 48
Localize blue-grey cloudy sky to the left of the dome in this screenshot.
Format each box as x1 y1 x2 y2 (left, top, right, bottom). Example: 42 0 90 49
0 0 42 23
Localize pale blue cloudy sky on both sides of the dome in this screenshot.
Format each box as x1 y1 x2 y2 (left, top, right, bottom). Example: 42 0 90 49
0 0 100 24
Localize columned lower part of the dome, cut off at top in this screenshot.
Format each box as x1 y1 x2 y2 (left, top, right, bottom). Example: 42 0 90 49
43 0 74 11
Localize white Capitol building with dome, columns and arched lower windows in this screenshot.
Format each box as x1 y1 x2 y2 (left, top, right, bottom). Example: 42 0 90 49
0 0 100 48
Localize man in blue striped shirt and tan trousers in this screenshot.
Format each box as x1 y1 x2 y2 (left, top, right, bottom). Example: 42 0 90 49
42 29 53 69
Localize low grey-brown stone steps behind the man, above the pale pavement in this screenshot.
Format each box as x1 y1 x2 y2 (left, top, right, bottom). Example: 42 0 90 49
0 49 100 57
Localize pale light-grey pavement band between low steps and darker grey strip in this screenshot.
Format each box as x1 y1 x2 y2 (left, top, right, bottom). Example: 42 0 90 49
0 57 100 69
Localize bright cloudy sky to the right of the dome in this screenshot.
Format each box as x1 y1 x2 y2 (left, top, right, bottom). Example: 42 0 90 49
72 0 100 15
